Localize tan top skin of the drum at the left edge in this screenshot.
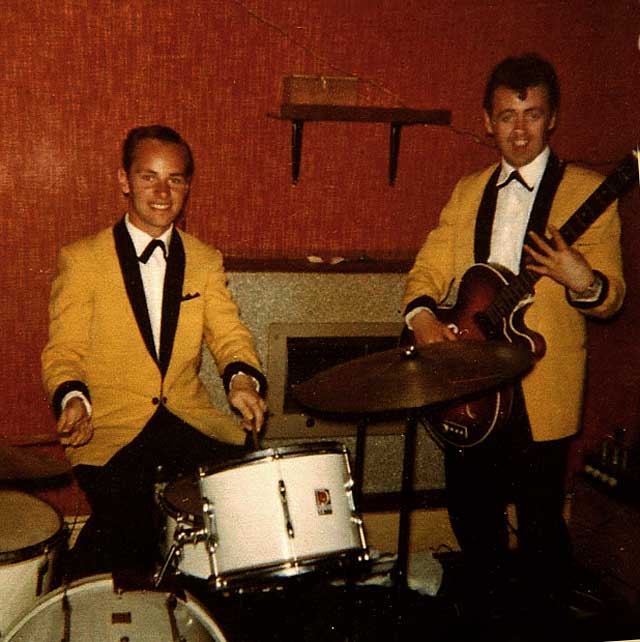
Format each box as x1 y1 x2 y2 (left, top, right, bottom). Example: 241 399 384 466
0 490 62 563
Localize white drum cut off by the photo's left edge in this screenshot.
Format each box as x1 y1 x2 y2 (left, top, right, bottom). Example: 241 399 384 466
0 490 65 637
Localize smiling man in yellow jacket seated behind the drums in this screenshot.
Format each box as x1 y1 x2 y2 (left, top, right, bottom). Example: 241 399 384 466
42 125 266 579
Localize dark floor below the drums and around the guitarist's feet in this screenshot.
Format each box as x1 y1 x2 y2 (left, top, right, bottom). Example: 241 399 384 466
172 560 640 642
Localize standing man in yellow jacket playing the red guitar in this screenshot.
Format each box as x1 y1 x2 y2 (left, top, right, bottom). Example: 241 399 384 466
403 54 625 639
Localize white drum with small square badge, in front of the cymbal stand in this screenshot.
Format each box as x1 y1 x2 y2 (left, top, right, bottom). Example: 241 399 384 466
199 442 368 588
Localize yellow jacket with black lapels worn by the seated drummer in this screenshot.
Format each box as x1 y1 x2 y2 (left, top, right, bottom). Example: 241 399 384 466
42 221 265 465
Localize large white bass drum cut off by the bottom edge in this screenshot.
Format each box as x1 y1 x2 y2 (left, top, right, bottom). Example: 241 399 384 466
2 575 226 642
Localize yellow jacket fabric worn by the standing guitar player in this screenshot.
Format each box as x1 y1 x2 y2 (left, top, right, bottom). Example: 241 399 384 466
403 159 625 441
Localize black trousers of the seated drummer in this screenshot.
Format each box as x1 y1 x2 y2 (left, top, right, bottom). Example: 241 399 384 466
68 406 246 579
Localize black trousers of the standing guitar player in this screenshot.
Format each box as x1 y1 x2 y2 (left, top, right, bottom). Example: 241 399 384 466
445 390 571 608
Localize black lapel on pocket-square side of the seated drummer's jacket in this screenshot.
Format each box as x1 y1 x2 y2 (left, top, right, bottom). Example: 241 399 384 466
160 228 185 376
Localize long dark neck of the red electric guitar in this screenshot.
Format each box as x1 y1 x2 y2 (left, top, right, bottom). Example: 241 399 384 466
487 154 638 322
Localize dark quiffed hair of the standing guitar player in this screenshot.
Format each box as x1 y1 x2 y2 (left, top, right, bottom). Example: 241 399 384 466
482 53 560 114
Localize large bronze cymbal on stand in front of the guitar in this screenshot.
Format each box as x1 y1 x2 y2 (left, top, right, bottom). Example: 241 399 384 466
293 341 533 414
